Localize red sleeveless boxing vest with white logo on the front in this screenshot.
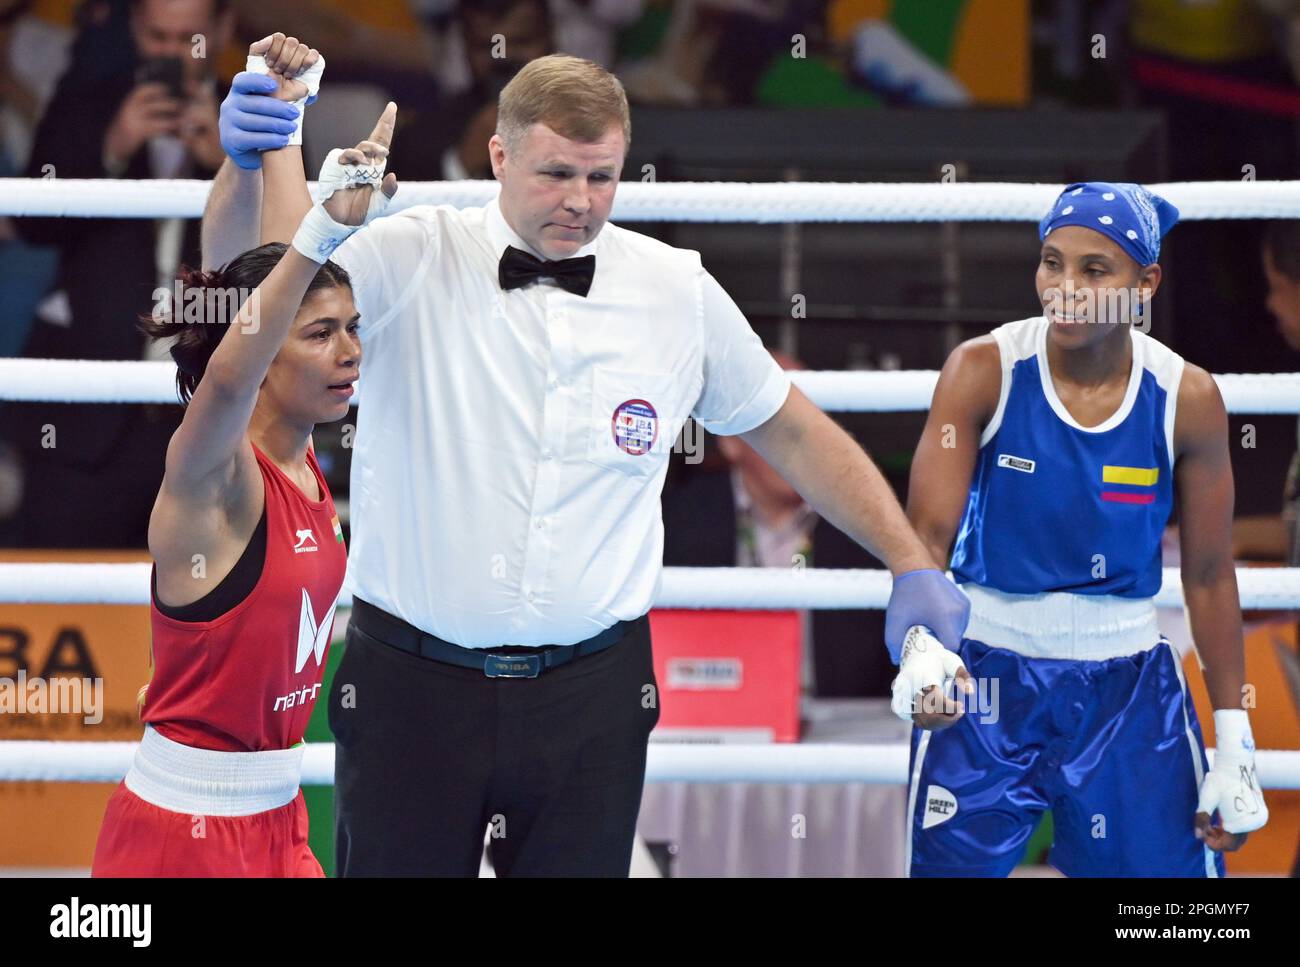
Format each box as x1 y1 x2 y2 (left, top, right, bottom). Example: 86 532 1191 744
140 446 347 753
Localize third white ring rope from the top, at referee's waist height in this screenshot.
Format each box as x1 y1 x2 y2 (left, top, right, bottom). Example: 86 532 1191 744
0 563 1300 611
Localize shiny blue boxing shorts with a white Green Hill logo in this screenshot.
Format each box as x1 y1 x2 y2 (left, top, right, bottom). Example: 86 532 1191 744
907 638 1223 877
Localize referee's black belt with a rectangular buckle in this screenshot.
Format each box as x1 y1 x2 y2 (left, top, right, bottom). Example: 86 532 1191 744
352 598 646 678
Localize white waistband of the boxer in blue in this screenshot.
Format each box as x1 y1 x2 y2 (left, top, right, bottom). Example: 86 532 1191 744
962 584 1160 662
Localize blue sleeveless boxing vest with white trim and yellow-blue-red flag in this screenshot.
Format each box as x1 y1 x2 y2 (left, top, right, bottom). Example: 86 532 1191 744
952 316 1183 598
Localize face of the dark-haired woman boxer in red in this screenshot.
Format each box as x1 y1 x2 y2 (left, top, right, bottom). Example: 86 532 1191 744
261 286 361 424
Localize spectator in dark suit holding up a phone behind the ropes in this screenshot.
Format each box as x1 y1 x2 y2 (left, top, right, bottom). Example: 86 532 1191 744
9 0 234 547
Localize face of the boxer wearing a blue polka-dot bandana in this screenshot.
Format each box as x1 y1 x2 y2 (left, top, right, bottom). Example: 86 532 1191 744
1035 225 1160 348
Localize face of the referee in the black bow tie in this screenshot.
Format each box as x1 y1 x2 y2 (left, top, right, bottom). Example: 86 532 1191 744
488 123 624 260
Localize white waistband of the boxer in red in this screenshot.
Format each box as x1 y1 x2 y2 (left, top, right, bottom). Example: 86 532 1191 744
126 725 303 816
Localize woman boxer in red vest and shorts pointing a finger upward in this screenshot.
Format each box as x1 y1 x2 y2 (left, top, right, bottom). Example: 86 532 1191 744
92 96 397 876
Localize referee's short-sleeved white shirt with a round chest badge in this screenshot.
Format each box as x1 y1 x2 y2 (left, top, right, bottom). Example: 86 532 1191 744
333 194 790 647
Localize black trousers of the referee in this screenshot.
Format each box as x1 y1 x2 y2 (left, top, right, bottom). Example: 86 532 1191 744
329 617 659 876
